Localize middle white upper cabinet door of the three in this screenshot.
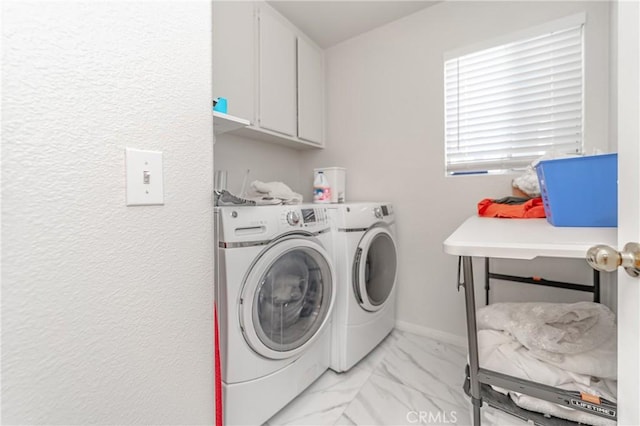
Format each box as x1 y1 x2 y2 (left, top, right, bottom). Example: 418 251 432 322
258 6 297 136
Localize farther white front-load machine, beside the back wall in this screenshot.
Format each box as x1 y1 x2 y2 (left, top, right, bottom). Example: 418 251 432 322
329 202 398 372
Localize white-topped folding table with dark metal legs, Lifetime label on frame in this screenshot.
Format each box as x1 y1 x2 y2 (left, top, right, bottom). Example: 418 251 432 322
444 216 617 426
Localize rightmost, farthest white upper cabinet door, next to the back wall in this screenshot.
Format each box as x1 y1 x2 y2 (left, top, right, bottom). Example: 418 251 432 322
298 38 324 145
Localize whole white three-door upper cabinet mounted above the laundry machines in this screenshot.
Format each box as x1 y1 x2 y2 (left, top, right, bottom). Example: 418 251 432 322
213 1 324 149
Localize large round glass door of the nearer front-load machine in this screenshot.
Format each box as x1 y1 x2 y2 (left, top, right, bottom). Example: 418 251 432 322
239 236 335 359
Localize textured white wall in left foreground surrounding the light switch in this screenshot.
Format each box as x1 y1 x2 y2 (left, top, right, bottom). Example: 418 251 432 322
2 1 214 424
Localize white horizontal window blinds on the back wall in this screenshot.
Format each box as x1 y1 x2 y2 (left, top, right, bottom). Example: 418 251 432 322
444 24 583 175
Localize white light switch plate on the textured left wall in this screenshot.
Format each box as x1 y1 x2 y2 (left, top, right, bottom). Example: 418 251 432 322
125 148 164 206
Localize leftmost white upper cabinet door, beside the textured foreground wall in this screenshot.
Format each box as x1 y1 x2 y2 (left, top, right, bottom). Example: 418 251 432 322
212 1 256 123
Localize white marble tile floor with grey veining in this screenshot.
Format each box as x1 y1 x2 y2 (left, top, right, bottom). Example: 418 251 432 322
263 330 527 426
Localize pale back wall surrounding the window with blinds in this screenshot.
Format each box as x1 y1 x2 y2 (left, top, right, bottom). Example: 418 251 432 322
301 1 609 335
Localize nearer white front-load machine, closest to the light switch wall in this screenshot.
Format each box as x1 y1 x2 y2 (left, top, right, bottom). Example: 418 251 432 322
215 205 336 425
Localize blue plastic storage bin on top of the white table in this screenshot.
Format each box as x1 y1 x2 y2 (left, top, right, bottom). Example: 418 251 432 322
536 154 618 227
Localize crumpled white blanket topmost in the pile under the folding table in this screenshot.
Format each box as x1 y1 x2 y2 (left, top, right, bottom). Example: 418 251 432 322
477 302 616 362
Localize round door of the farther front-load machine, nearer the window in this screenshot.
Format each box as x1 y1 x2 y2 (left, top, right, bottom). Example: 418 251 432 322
353 227 398 312
